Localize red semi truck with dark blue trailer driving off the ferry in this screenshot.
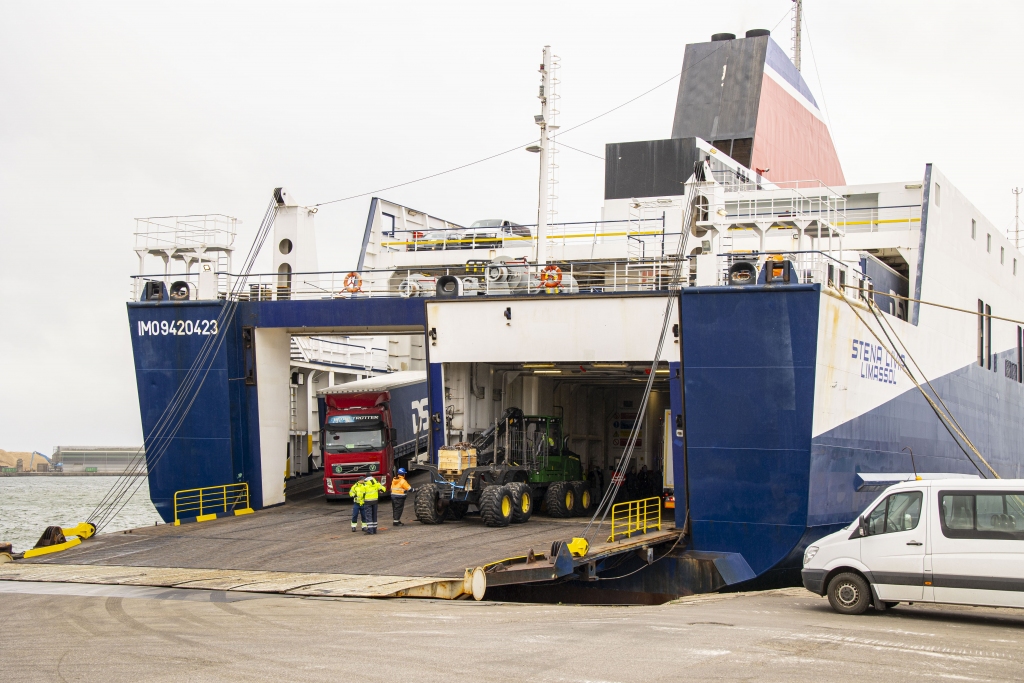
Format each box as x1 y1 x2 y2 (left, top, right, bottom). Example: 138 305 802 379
317 371 430 501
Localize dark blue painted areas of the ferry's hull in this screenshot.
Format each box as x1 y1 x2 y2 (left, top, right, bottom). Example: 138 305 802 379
128 285 1024 592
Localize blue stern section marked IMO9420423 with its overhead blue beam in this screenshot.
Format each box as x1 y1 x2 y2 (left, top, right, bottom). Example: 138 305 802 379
128 299 424 521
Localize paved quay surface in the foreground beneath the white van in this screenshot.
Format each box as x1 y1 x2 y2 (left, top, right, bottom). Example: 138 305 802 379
0 582 1024 683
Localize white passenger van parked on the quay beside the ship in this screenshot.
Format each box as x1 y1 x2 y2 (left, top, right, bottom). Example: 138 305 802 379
802 475 1024 614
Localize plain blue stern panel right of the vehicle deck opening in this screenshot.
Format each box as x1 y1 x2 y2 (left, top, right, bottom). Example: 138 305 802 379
682 285 820 574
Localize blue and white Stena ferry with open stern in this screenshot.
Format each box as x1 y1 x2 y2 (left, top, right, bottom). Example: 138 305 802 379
128 30 1024 584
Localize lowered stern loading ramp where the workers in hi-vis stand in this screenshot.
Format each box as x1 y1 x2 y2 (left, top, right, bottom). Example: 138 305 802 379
8 476 679 599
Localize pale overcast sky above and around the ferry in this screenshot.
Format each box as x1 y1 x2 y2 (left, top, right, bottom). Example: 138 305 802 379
0 0 1024 454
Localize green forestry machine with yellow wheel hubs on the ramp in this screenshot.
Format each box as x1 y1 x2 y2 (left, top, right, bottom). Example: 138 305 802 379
410 408 592 526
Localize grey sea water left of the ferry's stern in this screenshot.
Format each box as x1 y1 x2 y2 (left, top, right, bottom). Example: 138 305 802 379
0 475 164 552
